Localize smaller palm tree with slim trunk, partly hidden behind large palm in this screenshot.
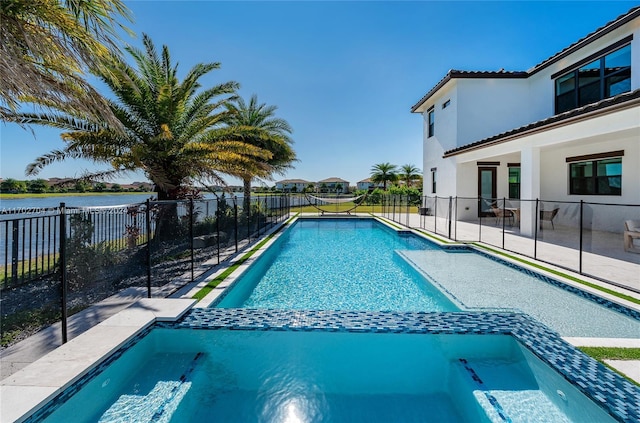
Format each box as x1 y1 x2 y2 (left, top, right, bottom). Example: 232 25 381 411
226 94 296 210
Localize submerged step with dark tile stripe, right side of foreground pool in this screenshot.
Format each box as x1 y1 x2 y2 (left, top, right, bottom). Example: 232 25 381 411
457 358 571 423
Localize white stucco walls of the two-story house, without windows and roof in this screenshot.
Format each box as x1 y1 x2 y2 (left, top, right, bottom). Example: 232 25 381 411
422 12 640 219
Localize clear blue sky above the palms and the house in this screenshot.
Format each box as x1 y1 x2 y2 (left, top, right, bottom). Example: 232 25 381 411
0 0 637 185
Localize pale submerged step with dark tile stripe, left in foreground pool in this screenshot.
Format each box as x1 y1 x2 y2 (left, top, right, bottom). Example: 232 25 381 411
99 353 203 423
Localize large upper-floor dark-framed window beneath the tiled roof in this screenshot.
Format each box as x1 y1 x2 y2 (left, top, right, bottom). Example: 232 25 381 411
555 44 631 114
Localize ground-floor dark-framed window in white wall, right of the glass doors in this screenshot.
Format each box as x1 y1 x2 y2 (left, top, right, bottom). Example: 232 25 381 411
569 157 622 195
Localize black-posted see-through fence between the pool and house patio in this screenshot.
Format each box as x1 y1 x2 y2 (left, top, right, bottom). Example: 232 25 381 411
382 196 640 292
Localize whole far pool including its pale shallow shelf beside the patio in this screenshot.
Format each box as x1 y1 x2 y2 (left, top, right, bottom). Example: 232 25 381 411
212 218 640 338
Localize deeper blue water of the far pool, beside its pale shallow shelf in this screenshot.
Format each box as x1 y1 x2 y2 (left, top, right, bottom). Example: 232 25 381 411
214 218 460 311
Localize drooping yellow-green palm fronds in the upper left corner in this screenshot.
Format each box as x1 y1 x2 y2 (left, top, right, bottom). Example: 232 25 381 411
0 0 131 126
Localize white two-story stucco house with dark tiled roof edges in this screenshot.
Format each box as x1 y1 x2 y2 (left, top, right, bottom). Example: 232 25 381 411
411 7 640 235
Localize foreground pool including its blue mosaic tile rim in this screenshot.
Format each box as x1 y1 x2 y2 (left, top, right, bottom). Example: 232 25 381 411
32 309 628 423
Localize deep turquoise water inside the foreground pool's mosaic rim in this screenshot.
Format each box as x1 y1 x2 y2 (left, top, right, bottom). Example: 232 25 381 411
40 329 613 423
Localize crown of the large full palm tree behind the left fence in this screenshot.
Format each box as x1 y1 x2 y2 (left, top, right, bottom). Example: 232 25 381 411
18 35 271 200
